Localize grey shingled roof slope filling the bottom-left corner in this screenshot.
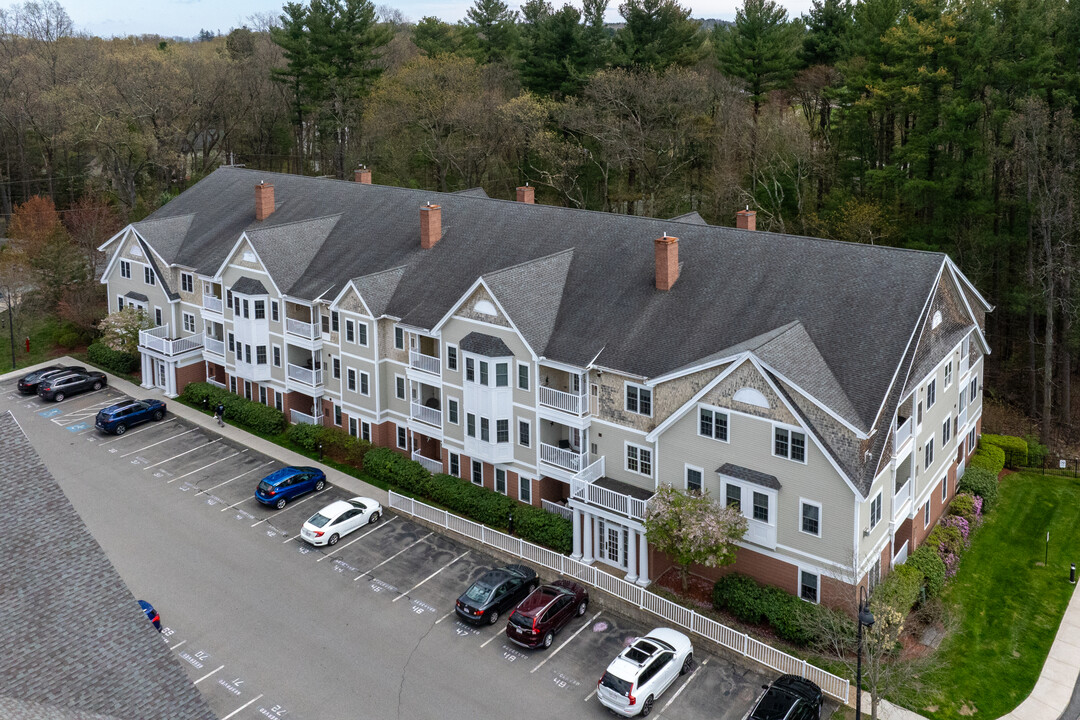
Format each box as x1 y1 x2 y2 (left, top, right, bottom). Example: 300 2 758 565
0 412 215 720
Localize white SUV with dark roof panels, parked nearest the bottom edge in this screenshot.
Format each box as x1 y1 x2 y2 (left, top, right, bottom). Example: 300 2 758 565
596 627 693 718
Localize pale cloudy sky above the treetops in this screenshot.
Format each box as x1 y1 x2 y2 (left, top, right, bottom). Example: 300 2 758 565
59 0 810 38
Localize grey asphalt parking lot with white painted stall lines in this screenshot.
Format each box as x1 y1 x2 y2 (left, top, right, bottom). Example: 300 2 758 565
0 381 834 720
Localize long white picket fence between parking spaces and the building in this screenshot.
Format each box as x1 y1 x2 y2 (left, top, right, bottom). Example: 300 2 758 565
390 490 851 703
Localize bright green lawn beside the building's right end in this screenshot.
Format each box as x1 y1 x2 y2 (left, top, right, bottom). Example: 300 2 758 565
913 473 1080 720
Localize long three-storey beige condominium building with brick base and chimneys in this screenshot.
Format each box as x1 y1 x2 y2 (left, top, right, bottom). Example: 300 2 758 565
102 167 991 602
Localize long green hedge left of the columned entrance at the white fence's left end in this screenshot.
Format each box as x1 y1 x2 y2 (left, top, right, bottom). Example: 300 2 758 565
364 448 573 553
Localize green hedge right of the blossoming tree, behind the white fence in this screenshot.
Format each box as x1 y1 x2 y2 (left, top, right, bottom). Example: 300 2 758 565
713 573 854 646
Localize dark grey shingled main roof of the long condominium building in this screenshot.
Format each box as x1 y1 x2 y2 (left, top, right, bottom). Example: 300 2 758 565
124 167 963 432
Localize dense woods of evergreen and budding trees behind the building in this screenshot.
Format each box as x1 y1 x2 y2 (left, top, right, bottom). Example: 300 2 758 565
0 0 1080 441
